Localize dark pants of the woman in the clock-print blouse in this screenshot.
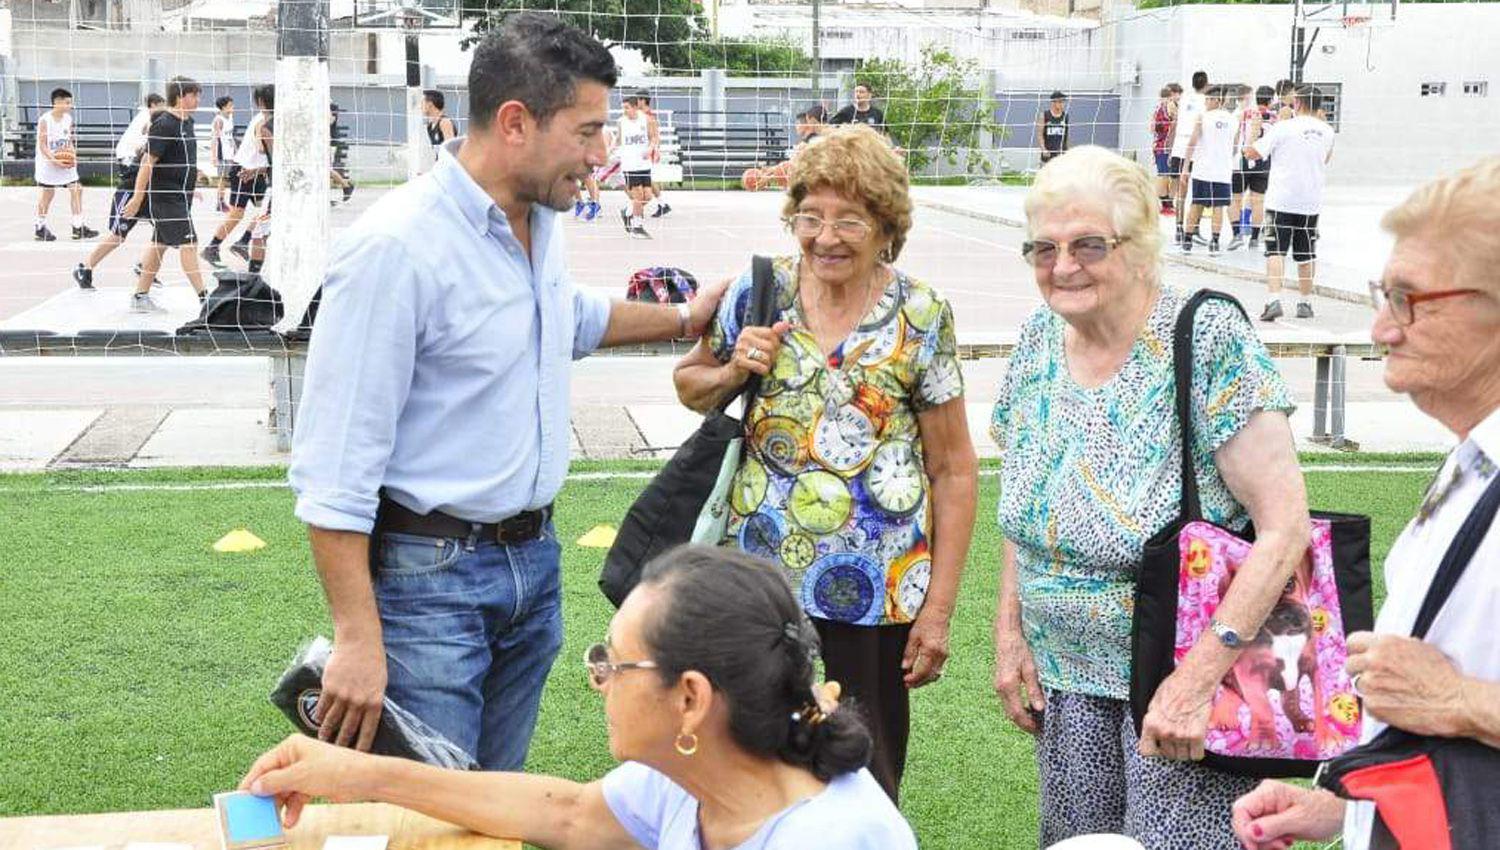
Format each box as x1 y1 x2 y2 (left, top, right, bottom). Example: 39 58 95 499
813 618 912 802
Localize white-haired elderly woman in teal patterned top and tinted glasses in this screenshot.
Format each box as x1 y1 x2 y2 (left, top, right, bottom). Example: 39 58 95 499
993 147 1310 850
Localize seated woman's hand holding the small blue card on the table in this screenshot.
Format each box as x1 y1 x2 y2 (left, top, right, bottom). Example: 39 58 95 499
240 735 374 829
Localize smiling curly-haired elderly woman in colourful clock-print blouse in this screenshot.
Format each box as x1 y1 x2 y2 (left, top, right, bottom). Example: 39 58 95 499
674 126 978 799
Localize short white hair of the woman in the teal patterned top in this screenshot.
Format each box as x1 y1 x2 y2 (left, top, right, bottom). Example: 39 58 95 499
1026 145 1161 276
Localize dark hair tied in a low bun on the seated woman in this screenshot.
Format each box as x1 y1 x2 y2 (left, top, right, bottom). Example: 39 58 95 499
641 546 872 781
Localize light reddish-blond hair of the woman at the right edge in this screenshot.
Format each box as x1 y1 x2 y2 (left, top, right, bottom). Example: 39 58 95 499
1380 156 1500 292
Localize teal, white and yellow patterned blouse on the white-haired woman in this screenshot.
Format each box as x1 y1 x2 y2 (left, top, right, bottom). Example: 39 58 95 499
990 288 1293 700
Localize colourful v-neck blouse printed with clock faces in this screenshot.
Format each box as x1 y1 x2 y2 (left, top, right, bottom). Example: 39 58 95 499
708 256 963 625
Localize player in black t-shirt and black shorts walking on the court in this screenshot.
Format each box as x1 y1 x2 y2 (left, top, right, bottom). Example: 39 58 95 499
125 76 206 313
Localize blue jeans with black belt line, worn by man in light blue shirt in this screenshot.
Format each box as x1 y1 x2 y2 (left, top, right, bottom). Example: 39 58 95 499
375 523 563 771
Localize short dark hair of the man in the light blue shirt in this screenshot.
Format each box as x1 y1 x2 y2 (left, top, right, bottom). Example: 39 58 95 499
470 12 620 130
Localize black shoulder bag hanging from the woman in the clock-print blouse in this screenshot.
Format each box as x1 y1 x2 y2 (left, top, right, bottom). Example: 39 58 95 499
599 256 776 607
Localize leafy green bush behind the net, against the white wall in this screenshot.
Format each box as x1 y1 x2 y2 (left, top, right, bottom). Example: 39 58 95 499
858 45 1008 174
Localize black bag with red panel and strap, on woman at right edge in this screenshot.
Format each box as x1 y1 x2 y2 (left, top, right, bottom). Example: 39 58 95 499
1317 477 1500 850
